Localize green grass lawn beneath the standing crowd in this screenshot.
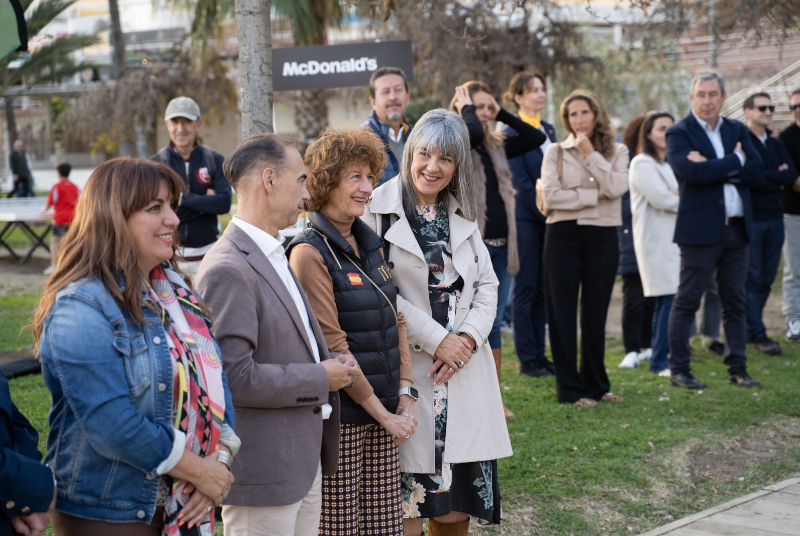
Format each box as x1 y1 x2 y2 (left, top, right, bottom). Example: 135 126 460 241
0 284 800 536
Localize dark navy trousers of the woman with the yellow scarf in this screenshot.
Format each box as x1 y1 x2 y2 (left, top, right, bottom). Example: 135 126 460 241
513 220 547 363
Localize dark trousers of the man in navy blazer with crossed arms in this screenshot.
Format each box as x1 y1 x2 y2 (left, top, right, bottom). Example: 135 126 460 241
669 221 750 374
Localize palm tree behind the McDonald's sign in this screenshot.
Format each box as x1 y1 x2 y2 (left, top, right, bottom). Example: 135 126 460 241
173 0 345 141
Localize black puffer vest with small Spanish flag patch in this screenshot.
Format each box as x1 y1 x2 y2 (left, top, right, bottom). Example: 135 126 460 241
286 212 400 424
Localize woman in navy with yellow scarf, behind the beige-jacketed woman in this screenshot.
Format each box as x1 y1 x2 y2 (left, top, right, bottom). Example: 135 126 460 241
503 71 556 377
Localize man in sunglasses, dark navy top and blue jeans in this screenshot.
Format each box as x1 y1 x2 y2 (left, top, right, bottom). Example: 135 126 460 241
742 93 797 355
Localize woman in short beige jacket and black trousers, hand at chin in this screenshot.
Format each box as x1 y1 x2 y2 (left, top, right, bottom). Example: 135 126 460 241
540 89 628 406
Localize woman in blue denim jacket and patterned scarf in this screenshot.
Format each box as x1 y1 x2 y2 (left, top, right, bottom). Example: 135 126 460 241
33 158 239 536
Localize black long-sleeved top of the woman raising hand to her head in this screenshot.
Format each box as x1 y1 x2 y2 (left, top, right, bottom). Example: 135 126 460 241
461 104 547 238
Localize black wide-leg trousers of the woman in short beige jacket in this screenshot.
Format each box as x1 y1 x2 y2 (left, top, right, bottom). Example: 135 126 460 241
544 221 619 402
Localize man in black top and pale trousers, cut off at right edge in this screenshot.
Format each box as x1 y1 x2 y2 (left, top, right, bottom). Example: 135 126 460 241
779 88 800 341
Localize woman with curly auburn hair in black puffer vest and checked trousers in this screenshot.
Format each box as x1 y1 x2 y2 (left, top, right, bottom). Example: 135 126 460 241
287 127 417 536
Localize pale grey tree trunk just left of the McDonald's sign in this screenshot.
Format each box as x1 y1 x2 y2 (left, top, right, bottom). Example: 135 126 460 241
236 0 273 138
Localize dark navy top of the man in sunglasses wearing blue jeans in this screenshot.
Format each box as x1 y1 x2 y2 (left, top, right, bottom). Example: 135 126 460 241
750 130 797 221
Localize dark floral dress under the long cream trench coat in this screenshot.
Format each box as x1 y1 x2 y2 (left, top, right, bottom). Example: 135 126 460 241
402 205 502 524
